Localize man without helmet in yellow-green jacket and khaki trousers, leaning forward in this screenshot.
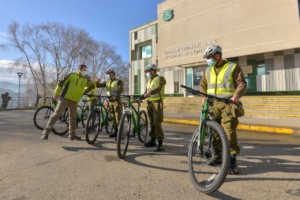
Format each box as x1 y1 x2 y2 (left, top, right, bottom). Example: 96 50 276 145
41 65 94 140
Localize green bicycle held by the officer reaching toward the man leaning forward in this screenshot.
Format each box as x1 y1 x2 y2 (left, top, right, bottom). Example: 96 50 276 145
85 94 115 144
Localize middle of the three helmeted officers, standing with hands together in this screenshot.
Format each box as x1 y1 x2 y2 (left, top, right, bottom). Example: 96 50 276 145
142 64 166 151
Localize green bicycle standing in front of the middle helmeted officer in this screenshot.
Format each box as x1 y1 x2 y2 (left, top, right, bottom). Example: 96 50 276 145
117 95 148 159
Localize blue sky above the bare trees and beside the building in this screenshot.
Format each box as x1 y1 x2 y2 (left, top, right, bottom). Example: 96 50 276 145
0 0 164 83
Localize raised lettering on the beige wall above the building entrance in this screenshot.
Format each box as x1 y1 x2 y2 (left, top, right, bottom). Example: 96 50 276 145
165 39 217 60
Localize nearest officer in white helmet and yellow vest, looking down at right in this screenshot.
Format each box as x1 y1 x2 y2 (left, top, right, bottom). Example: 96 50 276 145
200 45 247 174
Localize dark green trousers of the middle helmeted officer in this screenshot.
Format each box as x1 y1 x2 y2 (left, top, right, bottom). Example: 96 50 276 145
147 101 164 140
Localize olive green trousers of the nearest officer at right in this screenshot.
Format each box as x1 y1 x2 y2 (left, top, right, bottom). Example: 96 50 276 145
209 100 240 155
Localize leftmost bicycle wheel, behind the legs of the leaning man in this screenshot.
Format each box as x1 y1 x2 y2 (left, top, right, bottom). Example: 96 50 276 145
33 106 54 130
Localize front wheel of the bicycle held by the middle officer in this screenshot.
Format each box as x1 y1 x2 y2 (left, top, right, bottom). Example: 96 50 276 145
117 112 131 158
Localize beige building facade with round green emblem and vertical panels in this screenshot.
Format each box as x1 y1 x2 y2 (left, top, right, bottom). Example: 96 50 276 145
130 0 300 95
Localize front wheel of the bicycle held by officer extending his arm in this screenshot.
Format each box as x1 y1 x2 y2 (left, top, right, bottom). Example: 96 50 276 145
85 110 101 144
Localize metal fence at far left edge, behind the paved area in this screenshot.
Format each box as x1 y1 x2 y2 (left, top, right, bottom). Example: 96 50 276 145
0 97 36 110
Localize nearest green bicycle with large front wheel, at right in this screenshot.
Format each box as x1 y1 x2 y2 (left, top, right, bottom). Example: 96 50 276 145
181 85 231 194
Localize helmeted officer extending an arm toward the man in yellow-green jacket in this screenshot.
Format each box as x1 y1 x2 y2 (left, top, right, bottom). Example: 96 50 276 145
97 69 124 137
